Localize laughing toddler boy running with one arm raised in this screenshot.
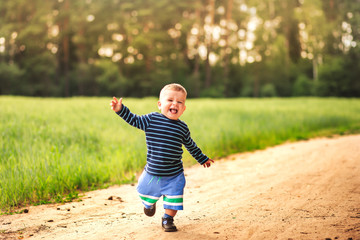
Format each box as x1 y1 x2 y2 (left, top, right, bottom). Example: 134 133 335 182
110 83 214 232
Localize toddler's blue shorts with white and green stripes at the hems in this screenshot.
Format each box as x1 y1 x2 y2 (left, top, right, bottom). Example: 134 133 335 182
137 171 186 210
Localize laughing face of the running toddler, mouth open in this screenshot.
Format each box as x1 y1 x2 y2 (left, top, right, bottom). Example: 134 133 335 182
158 89 186 120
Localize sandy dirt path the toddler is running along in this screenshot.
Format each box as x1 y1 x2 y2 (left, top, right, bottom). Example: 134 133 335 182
0 135 360 240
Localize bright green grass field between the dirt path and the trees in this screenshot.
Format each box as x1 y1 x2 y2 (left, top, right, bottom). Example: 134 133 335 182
0 96 360 212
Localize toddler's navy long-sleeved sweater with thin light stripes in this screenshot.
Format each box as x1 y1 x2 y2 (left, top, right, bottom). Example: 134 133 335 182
117 105 209 176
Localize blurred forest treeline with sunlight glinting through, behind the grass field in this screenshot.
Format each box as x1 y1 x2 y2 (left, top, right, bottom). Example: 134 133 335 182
0 0 360 97
